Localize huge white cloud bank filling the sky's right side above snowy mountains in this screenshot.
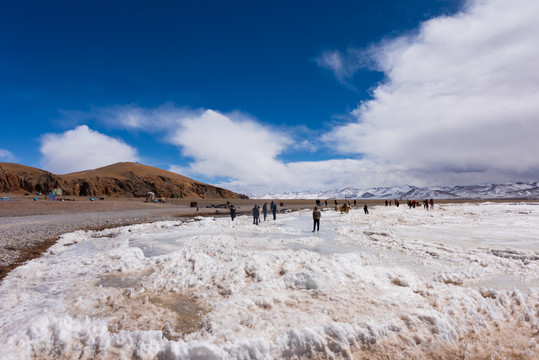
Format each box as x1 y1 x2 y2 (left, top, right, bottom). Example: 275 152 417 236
326 0 539 184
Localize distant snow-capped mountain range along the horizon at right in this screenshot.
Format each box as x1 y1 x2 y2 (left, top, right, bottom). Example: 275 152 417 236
258 181 539 200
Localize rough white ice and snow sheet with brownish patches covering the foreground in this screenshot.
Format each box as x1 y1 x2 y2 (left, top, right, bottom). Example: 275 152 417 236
0 203 539 359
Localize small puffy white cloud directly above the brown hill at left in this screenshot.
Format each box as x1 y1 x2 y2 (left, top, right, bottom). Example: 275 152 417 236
40 125 138 174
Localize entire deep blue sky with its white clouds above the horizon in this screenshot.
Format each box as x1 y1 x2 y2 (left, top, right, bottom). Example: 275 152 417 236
0 0 539 194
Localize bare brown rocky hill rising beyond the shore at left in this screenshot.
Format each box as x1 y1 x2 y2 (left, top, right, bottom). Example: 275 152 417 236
0 162 248 199
